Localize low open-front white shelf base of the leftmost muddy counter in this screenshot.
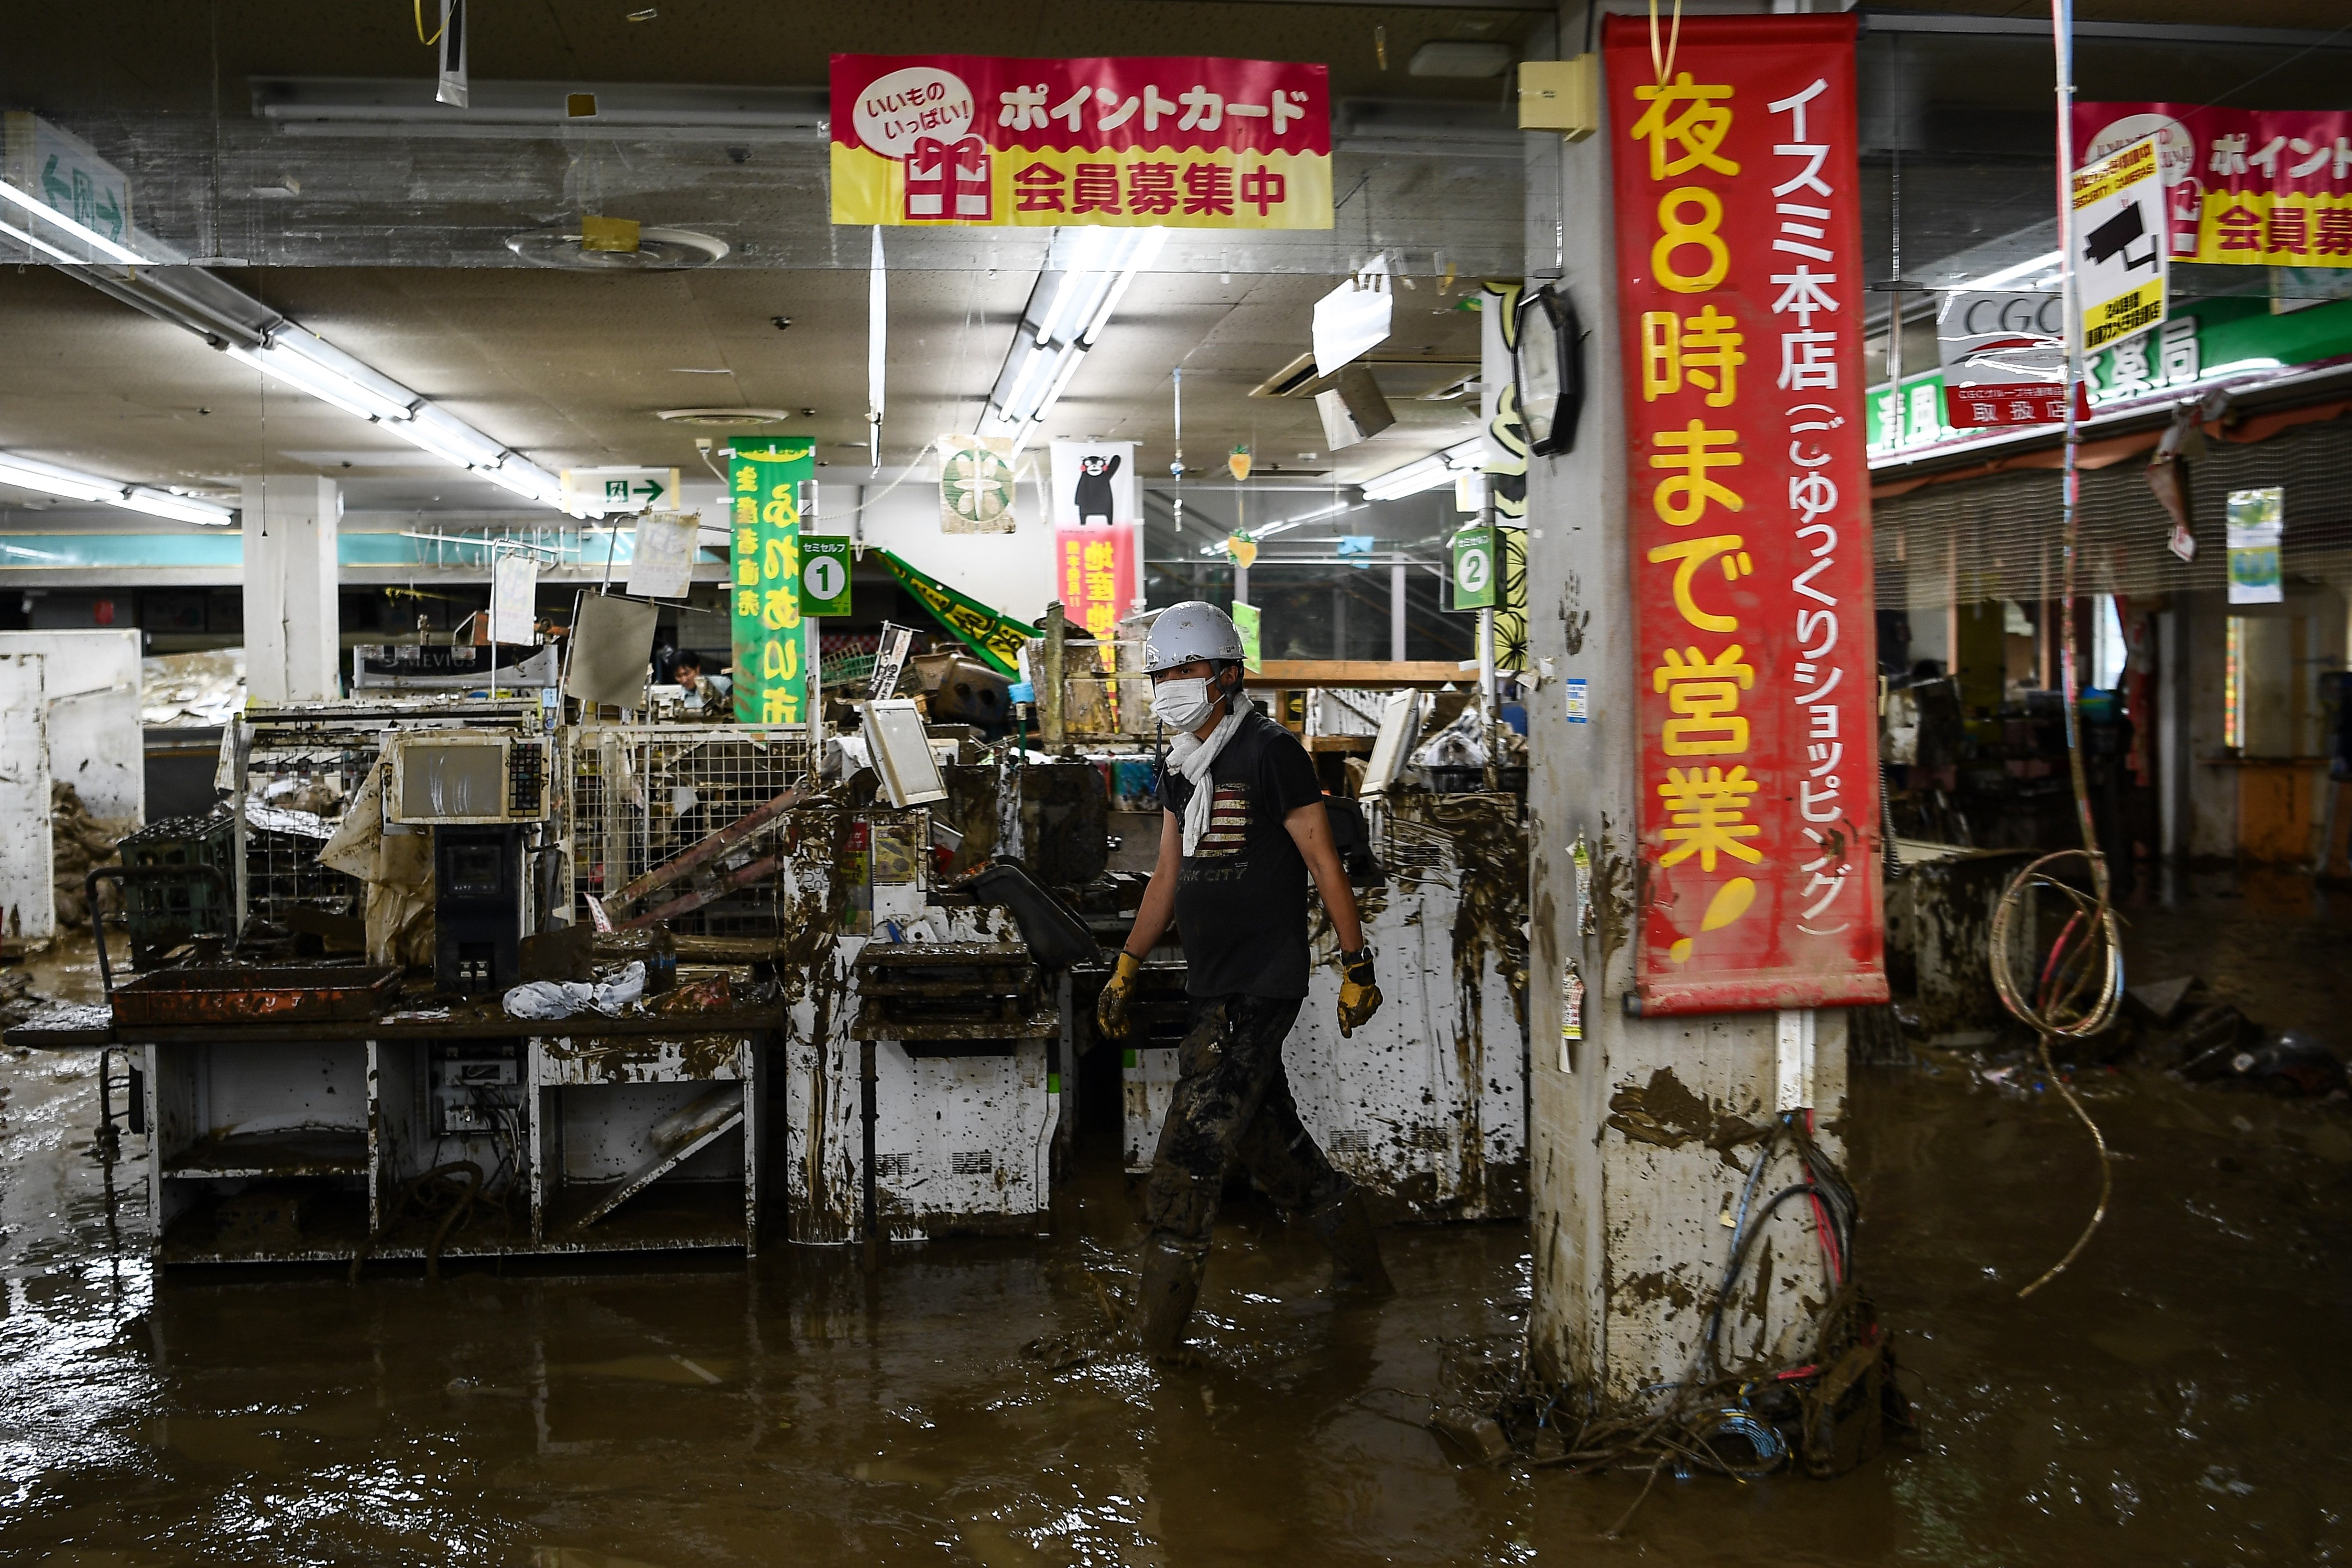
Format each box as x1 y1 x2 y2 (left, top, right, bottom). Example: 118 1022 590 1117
12 1004 781 1265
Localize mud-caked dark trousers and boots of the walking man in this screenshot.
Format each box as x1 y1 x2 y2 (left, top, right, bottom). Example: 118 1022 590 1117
1143 997 1388 1354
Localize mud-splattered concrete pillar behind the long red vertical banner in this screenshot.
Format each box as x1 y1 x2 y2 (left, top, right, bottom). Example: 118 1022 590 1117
1527 5 1846 1408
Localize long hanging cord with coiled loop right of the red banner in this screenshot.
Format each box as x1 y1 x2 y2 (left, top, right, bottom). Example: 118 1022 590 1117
1992 0 2124 1300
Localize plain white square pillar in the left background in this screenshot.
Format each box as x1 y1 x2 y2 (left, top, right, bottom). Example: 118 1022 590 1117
245 475 343 703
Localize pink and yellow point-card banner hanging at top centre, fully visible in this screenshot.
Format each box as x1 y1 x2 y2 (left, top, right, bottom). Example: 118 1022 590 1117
833 54 1331 228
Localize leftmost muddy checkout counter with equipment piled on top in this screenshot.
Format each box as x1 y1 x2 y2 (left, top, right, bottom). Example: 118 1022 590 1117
9 696 804 1262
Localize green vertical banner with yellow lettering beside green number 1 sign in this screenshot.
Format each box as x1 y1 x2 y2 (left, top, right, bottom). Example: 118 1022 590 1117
727 435 816 724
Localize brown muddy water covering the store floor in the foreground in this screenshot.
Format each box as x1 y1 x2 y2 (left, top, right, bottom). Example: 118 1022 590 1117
0 879 2352 1568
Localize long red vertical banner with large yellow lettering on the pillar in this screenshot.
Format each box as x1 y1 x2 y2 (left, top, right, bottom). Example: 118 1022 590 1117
1604 14 1886 1013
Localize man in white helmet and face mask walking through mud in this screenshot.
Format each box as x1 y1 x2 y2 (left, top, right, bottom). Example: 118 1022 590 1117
1096 602 1390 1356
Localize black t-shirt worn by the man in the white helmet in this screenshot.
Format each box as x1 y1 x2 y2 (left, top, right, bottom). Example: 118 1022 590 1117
1160 710 1322 997
